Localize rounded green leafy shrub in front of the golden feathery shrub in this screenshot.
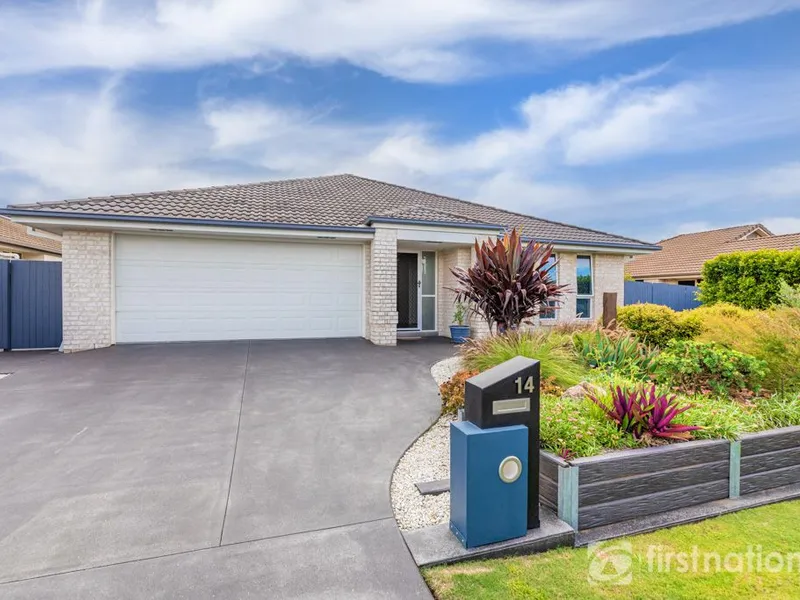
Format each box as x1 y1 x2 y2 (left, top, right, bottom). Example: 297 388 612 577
657 341 766 395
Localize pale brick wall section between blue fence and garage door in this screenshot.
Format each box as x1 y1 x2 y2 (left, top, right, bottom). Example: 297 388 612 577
61 231 114 352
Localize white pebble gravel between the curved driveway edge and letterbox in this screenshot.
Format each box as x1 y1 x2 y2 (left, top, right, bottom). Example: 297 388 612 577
392 357 461 530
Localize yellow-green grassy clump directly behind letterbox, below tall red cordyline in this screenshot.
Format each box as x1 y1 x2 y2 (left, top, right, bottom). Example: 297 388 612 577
460 330 586 388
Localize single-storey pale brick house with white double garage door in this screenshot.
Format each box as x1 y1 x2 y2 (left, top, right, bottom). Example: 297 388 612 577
2 175 657 351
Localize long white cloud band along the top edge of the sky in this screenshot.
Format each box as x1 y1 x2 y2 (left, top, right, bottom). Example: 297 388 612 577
0 0 800 81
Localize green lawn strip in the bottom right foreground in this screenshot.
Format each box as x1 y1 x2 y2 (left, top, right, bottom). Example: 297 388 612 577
423 501 800 600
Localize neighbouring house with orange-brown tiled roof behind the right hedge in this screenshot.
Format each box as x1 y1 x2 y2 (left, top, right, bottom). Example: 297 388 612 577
625 223 800 285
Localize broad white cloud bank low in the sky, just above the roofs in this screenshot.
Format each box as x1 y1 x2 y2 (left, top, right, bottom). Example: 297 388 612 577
0 72 800 246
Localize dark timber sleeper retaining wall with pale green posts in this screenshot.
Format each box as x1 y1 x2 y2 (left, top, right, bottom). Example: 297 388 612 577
540 427 800 530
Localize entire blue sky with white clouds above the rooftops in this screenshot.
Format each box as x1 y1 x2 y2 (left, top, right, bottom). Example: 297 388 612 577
0 0 800 241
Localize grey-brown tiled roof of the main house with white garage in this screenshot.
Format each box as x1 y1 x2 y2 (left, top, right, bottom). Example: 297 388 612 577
9 174 650 247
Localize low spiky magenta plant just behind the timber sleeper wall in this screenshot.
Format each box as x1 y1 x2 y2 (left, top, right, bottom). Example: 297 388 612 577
589 385 702 441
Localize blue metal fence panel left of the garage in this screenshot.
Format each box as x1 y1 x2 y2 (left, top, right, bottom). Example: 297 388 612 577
0 260 62 350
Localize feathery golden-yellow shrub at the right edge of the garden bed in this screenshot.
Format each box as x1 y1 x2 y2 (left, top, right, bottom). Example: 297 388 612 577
691 304 800 391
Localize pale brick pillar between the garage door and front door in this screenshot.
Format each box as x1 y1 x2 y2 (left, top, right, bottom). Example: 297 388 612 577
368 227 397 346
